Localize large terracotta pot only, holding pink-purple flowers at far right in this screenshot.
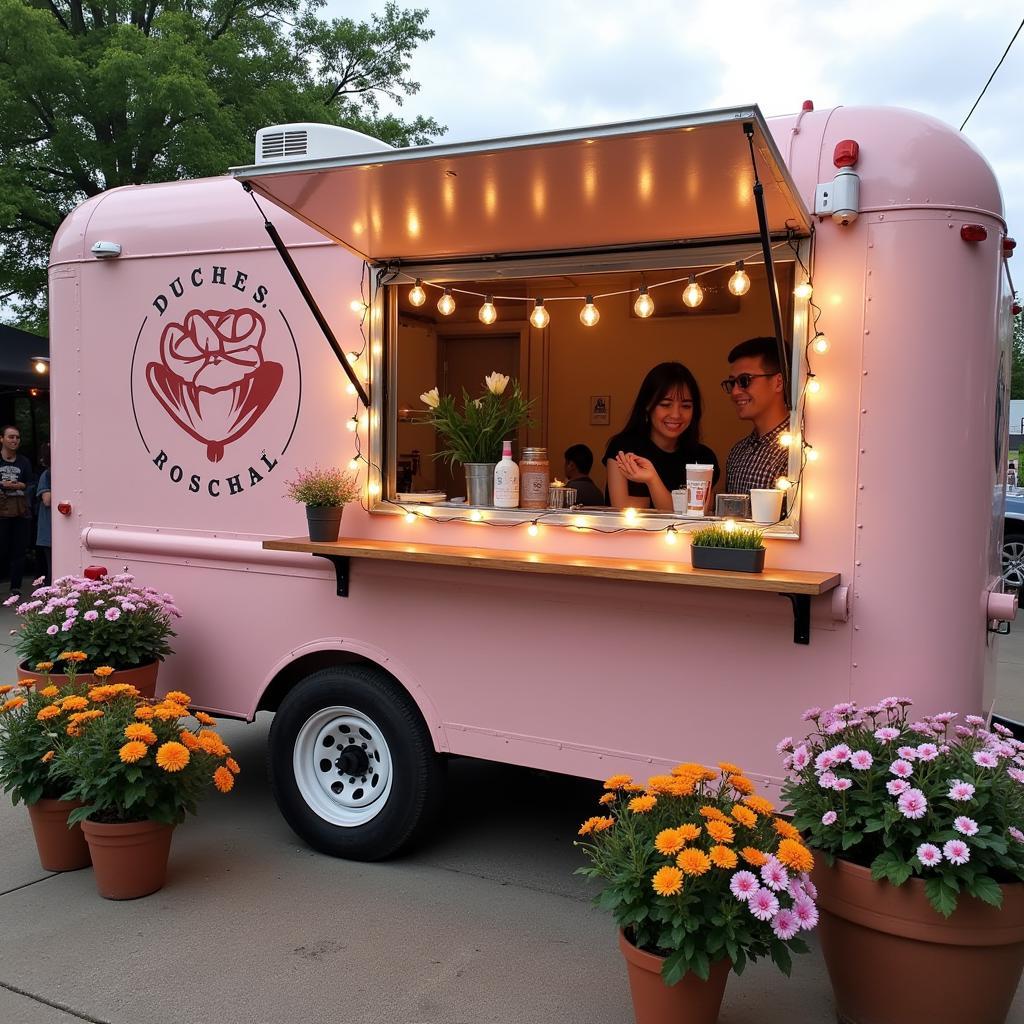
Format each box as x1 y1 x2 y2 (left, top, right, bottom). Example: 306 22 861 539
813 860 1024 1024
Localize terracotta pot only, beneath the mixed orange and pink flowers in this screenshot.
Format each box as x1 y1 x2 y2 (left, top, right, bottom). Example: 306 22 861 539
618 931 729 1024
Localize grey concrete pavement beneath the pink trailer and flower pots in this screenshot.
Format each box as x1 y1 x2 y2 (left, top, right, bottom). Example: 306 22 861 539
0 611 1024 1024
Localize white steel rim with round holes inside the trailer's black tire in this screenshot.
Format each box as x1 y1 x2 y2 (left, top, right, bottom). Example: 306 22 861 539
292 707 392 828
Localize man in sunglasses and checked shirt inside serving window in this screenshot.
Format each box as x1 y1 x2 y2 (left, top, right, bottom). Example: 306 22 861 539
722 338 790 495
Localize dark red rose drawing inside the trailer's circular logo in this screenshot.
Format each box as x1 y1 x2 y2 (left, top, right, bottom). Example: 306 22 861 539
145 309 284 462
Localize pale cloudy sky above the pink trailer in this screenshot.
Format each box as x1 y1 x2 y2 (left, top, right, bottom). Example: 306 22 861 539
327 0 1024 243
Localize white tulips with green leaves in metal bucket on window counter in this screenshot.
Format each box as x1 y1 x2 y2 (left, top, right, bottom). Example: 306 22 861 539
420 371 532 505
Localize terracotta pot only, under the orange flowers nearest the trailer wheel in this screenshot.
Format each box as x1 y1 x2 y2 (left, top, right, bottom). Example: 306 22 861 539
82 818 174 899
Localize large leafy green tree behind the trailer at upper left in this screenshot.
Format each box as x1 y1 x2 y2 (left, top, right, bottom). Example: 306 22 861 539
0 0 444 331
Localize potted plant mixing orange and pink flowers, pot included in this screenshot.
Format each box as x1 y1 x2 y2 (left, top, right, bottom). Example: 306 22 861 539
577 762 817 1024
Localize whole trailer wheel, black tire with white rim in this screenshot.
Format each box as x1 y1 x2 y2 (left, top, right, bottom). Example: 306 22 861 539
268 665 444 860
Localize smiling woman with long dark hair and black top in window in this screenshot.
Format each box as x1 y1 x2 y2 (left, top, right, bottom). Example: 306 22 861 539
601 362 719 512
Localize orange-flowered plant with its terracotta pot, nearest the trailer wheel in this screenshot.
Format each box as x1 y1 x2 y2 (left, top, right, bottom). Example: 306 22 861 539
51 684 239 899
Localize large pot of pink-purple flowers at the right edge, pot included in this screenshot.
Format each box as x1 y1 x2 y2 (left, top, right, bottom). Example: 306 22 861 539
779 696 1024 1024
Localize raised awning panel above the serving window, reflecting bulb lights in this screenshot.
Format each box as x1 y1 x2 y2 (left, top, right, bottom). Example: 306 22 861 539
231 105 810 263
